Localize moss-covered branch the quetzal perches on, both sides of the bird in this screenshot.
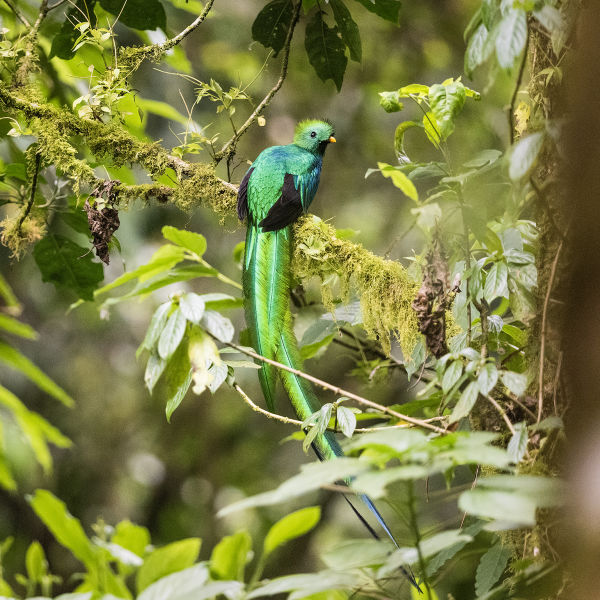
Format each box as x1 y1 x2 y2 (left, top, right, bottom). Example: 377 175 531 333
0 84 419 357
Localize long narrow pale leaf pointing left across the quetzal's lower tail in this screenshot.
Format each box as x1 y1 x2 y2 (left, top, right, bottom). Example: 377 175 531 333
218 457 370 517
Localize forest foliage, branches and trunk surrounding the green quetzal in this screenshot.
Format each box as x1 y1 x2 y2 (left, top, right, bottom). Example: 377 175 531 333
0 0 600 599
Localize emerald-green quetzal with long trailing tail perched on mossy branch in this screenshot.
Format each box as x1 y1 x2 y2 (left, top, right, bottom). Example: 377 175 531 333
237 120 418 588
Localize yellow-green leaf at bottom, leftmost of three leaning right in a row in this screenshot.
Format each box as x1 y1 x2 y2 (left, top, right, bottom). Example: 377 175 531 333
136 538 201 600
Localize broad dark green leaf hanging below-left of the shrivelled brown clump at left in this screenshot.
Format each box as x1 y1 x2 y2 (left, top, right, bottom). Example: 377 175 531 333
33 234 104 300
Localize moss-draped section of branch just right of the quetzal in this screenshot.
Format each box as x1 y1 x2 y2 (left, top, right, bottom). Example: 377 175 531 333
293 217 419 355
